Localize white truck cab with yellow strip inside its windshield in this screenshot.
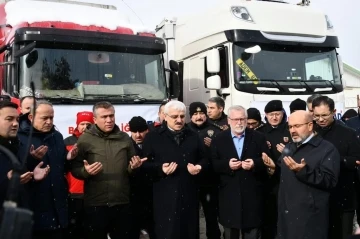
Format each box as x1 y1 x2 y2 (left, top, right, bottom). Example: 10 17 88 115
156 0 344 118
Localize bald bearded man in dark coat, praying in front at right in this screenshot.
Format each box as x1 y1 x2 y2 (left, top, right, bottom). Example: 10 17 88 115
264 110 340 239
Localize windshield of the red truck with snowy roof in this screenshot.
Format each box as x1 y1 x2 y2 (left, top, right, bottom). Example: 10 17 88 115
19 48 166 102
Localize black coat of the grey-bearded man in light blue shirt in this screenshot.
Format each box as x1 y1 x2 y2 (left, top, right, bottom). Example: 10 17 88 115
211 129 269 229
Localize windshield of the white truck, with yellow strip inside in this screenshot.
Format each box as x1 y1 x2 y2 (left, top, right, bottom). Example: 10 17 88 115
233 43 342 94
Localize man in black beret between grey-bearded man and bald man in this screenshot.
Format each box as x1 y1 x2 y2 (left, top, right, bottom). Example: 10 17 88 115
256 100 291 239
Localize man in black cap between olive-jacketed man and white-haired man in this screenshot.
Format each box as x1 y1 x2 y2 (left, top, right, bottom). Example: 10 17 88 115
129 116 155 239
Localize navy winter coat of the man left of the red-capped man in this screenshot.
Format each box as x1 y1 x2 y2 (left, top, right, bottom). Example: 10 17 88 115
18 117 68 230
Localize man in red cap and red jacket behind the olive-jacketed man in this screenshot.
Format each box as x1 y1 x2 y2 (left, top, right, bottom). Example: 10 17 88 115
64 111 94 239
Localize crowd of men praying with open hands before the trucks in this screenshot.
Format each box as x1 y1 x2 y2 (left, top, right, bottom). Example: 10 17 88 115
0 95 360 239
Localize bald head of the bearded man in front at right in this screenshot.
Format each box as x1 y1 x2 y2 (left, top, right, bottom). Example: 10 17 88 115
288 110 313 143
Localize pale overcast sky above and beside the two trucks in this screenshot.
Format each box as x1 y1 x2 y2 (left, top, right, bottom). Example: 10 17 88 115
82 0 360 70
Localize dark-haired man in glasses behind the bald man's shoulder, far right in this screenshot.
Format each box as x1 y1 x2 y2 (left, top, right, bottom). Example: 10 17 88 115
312 96 360 239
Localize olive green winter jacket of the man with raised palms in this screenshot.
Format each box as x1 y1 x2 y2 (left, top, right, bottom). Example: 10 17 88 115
71 125 135 207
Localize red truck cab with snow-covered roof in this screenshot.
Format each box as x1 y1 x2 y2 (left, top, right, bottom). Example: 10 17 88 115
0 0 179 136
